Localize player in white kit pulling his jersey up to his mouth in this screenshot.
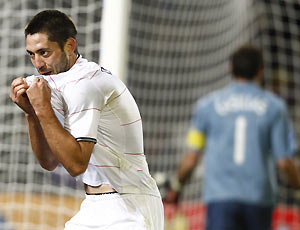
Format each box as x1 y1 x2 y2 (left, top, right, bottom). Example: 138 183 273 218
10 10 164 230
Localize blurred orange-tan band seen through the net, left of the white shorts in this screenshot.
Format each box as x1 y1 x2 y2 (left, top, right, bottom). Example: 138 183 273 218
0 193 83 230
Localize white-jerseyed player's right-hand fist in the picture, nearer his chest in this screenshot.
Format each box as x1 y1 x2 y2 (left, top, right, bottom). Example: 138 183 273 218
26 78 52 115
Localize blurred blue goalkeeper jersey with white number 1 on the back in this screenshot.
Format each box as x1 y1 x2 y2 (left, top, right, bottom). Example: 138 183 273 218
189 82 296 205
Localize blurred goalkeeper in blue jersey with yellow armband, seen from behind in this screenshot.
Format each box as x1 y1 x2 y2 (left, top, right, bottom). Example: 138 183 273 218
165 45 300 230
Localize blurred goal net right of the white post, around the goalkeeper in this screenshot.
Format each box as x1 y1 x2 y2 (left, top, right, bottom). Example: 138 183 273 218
127 0 300 229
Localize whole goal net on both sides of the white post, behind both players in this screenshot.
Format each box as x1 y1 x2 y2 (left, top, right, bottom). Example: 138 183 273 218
0 0 300 230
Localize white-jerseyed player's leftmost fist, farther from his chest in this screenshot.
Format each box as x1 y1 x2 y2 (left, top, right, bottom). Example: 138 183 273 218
9 77 34 114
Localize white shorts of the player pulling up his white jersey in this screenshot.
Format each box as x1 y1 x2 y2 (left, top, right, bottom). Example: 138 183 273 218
65 193 164 230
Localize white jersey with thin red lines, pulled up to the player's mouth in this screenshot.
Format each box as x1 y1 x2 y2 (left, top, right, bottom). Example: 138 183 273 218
26 57 160 196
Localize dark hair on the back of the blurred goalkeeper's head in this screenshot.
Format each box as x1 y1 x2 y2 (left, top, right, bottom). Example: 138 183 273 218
231 44 263 80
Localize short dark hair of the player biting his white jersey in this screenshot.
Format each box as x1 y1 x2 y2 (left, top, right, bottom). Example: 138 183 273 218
25 10 77 53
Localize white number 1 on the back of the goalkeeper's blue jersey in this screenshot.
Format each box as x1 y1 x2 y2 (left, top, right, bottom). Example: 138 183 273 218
233 116 247 165
